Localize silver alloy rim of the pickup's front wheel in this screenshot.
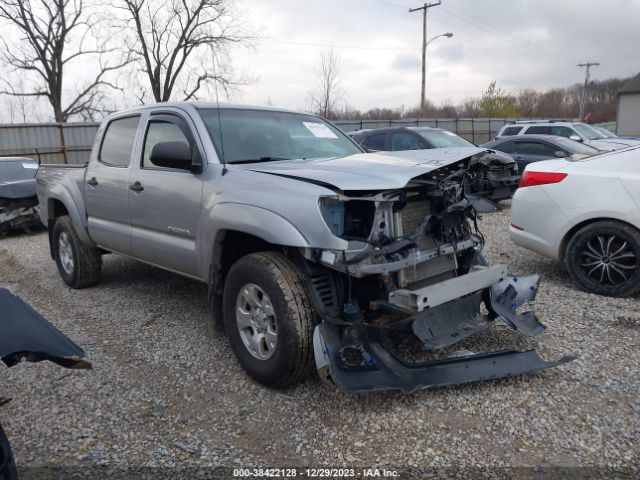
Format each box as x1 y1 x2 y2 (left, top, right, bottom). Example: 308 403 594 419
236 283 278 360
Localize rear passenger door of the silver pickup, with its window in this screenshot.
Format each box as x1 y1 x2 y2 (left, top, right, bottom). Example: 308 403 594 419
84 115 140 255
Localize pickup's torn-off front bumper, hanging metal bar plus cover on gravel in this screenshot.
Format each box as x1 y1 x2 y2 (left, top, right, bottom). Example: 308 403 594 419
314 266 575 392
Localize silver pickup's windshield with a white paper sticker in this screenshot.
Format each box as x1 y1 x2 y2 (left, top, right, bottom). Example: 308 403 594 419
200 108 362 163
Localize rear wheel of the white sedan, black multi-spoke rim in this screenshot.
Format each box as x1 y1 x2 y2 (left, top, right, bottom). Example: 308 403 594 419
565 220 640 297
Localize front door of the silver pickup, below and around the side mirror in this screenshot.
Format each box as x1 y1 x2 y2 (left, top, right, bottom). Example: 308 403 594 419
128 111 206 277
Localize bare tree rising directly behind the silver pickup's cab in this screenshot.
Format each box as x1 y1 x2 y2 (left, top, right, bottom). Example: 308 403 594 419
115 0 250 103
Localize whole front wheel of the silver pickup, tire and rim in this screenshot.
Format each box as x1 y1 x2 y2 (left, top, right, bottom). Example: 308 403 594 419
223 252 316 388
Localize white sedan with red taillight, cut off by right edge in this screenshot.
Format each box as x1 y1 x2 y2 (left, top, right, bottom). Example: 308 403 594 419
510 146 640 297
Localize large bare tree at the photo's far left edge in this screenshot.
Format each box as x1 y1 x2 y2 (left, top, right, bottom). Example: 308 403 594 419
0 0 127 122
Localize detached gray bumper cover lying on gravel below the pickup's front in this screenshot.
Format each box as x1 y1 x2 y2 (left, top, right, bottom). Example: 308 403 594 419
314 322 575 393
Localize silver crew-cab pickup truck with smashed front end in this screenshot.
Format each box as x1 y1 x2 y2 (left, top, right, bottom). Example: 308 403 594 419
37 103 570 391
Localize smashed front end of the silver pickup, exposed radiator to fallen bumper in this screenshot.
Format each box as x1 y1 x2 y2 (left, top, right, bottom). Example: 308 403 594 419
288 155 572 392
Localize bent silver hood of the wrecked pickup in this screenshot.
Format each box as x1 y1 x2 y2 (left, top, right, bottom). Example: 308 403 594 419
235 147 486 191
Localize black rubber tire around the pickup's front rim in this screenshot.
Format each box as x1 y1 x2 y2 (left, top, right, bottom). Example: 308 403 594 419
223 252 317 388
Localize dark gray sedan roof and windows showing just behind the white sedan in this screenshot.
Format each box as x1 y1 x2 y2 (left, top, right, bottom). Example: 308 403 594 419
482 135 600 172
